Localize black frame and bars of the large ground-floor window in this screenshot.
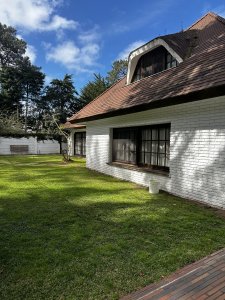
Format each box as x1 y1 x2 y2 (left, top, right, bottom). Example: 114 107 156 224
112 123 171 172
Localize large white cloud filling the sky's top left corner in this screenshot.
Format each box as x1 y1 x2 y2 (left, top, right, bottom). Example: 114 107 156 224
0 0 78 31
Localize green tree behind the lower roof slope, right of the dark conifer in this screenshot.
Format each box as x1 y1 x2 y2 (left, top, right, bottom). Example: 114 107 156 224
80 74 109 108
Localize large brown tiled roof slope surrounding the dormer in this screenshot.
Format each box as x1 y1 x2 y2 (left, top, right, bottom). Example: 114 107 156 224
69 13 225 123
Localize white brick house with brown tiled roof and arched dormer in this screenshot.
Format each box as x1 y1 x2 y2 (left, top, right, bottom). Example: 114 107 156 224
69 12 225 208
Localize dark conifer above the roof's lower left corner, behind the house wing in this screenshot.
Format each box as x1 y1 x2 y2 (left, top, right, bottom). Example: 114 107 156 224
43 74 78 123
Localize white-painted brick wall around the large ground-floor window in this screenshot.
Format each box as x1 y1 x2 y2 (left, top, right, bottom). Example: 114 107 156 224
86 97 225 208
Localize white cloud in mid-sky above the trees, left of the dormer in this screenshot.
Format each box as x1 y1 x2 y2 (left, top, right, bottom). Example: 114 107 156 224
46 40 100 72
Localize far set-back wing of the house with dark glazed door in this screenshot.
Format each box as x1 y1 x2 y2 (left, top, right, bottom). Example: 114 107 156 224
63 122 86 157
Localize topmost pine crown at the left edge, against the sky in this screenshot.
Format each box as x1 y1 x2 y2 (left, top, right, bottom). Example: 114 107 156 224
0 23 26 67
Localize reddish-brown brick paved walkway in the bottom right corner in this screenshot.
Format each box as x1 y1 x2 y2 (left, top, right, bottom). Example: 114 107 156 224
122 248 225 300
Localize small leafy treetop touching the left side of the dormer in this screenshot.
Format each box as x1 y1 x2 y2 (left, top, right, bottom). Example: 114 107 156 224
106 59 128 85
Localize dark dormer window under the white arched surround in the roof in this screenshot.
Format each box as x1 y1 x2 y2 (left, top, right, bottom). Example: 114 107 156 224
132 46 178 82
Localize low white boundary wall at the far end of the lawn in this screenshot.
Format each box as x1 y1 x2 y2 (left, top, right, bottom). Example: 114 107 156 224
0 137 65 155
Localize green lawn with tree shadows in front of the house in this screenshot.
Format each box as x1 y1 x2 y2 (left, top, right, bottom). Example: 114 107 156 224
0 156 225 300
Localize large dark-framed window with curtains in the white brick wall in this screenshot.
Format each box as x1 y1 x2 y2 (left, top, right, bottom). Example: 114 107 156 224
112 124 170 171
